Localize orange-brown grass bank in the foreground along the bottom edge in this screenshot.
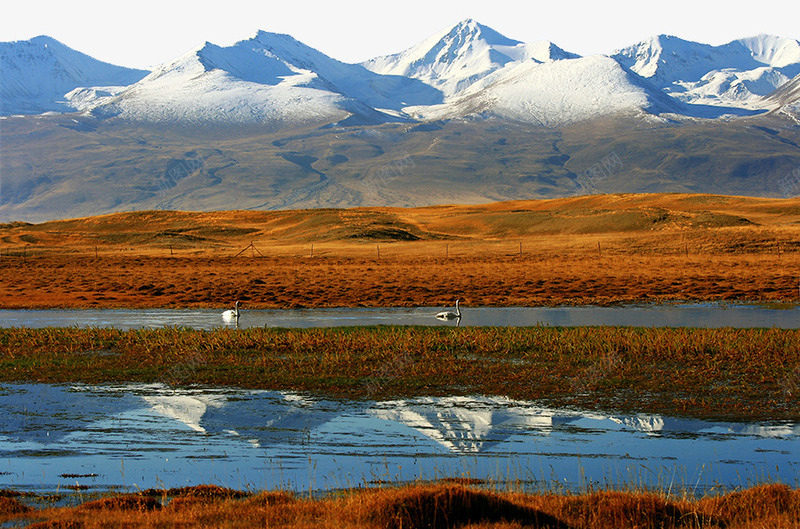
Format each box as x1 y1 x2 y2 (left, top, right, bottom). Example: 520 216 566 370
0 482 800 529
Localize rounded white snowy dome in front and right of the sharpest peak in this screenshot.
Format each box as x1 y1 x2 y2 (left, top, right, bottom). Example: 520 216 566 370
409 55 680 127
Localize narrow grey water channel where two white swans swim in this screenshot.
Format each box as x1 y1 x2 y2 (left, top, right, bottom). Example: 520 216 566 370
0 304 800 329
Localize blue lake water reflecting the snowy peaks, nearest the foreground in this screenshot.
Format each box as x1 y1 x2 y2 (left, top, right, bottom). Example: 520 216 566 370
0 384 800 492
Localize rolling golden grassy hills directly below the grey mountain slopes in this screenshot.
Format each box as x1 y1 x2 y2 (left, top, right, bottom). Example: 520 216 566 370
0 194 800 251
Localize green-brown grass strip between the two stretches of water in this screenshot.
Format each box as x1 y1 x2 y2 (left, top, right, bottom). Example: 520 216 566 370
0 327 800 421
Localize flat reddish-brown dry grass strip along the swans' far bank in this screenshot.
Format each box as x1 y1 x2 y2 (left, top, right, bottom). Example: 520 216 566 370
0 250 800 309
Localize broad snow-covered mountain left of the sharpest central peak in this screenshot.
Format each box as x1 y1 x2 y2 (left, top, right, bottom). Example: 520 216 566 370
87 31 441 123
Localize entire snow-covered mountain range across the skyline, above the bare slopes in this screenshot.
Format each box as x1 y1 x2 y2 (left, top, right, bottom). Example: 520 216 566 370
0 20 800 127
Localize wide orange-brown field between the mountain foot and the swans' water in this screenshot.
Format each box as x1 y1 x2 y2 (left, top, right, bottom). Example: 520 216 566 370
0 194 800 308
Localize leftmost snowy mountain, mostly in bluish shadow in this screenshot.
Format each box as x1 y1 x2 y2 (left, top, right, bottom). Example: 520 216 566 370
0 36 147 115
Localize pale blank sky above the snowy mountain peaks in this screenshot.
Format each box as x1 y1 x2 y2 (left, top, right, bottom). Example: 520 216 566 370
0 0 800 68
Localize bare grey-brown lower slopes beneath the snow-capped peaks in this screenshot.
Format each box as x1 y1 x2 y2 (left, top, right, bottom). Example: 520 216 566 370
0 114 800 222
